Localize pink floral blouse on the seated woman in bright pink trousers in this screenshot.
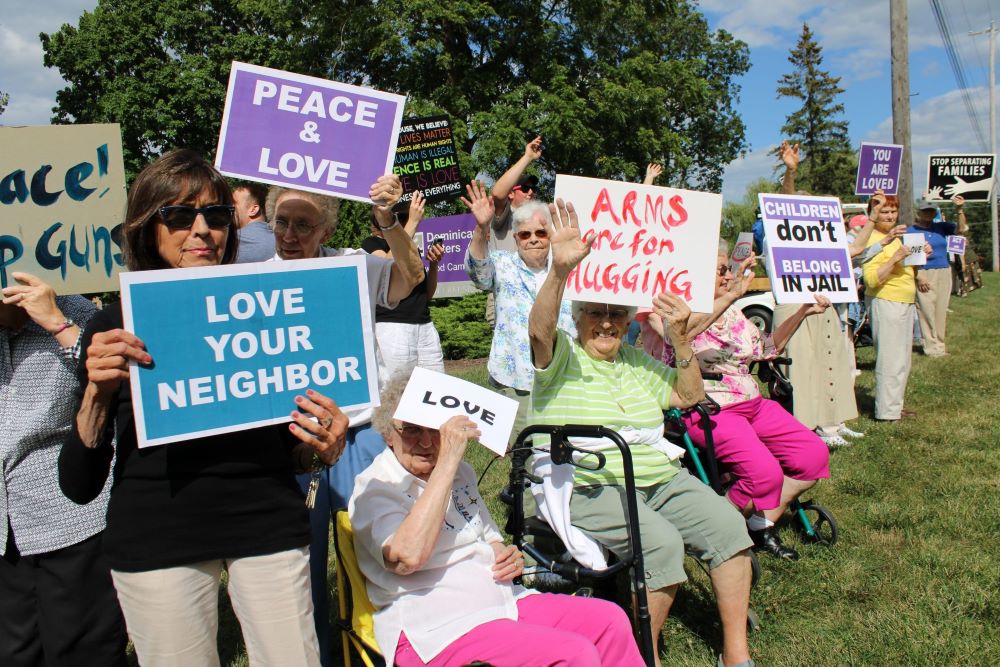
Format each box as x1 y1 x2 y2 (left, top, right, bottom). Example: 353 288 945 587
642 306 778 407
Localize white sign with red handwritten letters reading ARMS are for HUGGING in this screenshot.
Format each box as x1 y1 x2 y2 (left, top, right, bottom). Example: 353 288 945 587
556 174 722 313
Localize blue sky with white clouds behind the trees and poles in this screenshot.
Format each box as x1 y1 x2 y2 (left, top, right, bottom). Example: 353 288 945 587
0 0 1000 199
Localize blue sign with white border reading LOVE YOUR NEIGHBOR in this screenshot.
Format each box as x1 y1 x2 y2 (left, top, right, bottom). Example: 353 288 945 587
121 255 378 447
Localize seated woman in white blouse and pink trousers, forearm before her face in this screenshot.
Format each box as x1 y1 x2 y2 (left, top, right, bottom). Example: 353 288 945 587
348 373 643 667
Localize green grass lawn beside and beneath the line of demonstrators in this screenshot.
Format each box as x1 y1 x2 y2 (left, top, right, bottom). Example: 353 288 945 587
220 274 1000 667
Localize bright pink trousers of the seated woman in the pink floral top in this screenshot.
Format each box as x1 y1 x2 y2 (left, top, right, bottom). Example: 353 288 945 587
684 396 830 511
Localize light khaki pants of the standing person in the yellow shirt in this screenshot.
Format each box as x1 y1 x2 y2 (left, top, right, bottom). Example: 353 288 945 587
870 299 914 419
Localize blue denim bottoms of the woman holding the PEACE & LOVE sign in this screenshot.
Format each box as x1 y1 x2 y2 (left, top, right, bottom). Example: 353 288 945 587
298 423 386 667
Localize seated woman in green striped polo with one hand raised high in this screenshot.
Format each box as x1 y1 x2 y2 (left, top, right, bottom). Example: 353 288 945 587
528 201 753 667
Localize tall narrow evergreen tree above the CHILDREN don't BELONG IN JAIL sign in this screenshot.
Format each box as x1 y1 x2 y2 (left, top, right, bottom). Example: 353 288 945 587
778 23 857 197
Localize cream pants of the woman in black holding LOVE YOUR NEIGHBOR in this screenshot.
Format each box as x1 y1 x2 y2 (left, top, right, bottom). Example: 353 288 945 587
111 547 319 667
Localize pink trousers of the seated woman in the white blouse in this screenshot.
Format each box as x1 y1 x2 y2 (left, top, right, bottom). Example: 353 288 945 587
396 593 644 667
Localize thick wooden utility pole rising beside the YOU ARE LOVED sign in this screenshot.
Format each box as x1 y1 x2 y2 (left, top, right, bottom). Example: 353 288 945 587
889 0 913 225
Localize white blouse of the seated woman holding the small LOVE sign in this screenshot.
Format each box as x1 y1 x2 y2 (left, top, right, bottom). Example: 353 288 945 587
347 449 534 662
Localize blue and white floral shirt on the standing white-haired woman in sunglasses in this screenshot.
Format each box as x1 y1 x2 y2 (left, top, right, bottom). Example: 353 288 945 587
465 250 576 391
